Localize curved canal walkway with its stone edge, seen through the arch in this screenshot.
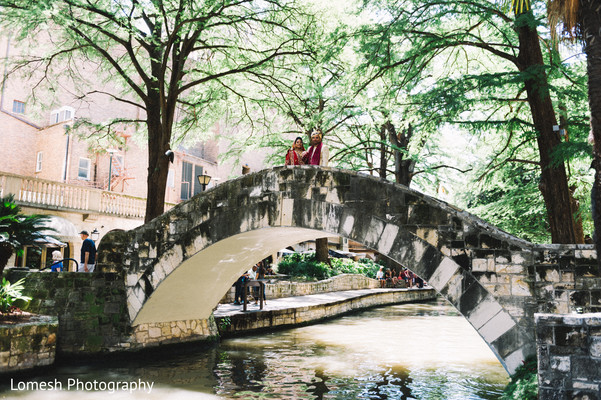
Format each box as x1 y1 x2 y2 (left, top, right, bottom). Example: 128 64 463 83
214 289 437 337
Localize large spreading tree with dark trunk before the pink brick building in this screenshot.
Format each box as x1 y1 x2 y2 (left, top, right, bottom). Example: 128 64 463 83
0 0 311 221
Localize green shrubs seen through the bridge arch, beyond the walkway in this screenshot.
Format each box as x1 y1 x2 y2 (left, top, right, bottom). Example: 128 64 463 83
278 253 381 280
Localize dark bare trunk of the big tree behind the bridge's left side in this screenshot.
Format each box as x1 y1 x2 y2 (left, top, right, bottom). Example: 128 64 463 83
144 96 171 222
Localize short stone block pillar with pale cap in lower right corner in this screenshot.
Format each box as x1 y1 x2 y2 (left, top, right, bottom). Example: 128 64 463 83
535 313 601 400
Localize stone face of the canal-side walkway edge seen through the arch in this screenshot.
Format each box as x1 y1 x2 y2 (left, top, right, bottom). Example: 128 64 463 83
215 289 438 336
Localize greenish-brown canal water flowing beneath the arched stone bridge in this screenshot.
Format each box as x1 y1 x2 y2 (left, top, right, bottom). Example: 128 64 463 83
0 301 508 400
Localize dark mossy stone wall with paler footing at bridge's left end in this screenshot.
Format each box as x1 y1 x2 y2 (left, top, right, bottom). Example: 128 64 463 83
7 270 218 354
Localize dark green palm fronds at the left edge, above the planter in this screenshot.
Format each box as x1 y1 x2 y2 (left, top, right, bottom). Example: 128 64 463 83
0 194 53 277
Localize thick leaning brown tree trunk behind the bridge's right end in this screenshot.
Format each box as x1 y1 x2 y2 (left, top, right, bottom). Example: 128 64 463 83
516 12 584 243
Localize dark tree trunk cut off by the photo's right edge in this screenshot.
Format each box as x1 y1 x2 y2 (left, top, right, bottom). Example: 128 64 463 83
580 0 601 266
